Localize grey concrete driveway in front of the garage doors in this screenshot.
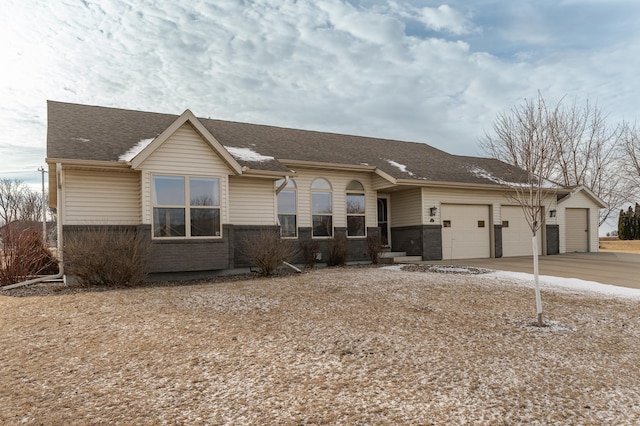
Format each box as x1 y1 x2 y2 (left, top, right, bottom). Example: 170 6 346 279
427 252 640 288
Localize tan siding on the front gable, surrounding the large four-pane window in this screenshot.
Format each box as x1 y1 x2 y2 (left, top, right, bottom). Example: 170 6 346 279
139 124 231 223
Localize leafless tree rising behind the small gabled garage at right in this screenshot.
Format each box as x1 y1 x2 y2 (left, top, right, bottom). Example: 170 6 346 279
551 100 629 225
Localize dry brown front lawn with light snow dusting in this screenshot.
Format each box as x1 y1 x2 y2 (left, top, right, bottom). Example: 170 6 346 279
0 268 640 425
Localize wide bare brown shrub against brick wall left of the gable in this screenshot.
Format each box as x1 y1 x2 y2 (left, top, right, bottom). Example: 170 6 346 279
64 227 151 287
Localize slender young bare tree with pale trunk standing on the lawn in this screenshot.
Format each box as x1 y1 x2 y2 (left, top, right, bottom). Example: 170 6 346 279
481 94 559 326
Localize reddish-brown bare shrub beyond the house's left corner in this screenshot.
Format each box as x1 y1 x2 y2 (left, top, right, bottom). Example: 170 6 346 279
0 227 58 285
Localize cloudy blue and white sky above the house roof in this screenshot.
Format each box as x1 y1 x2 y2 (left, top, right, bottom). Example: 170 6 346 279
0 0 640 186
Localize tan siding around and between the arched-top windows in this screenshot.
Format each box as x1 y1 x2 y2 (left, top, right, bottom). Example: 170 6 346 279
293 167 378 231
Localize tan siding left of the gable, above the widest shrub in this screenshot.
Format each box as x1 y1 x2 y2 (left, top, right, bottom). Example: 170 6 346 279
61 170 141 225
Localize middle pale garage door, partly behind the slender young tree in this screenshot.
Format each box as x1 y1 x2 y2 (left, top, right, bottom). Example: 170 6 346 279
501 206 542 257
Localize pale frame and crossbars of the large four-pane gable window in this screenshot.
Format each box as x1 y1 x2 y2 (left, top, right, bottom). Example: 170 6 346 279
150 173 224 241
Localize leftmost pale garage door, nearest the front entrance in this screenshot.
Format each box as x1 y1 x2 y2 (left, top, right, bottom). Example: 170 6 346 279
441 204 491 259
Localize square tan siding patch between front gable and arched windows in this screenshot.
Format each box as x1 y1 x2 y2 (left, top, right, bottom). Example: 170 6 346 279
229 177 276 225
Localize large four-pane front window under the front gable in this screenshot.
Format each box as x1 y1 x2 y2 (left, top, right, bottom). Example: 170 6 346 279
153 176 221 238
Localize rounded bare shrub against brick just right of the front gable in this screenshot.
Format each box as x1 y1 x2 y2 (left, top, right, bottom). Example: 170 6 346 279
241 229 298 276
